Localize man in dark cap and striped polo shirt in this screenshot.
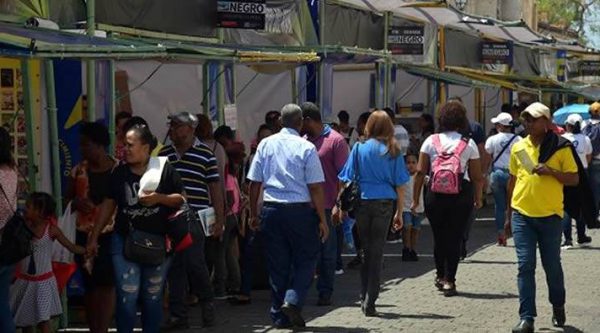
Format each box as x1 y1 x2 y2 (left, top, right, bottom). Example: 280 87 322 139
159 112 225 329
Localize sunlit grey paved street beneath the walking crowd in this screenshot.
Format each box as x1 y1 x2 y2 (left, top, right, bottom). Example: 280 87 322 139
188 208 600 333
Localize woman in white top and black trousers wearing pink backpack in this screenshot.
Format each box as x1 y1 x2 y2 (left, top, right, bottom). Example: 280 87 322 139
413 101 483 297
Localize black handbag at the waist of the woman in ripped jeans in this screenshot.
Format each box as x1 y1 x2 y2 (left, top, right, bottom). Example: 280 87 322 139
123 222 167 266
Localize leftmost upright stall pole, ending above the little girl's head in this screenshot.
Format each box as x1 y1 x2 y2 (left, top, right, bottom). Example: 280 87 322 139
21 59 38 192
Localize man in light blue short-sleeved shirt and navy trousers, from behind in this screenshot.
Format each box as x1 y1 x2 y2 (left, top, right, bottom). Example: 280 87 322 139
248 104 329 328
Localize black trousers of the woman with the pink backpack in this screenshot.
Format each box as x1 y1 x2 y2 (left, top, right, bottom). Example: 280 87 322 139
425 181 473 282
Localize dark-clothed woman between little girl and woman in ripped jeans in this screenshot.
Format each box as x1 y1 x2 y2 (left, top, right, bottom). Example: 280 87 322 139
67 123 117 333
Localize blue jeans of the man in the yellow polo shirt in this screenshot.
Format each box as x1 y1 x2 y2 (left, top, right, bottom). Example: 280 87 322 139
512 211 565 321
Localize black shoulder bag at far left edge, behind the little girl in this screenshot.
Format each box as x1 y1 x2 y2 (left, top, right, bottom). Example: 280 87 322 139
0 185 33 266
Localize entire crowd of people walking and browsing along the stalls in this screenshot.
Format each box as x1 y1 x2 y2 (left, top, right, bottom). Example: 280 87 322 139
0 98 600 333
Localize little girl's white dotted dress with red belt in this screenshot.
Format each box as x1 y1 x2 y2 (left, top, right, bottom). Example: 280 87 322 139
10 224 62 327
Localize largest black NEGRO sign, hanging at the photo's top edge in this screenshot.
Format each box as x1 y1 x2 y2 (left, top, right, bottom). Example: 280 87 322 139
217 0 267 30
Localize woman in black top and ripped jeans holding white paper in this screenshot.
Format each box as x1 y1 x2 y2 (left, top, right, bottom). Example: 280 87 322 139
87 126 184 333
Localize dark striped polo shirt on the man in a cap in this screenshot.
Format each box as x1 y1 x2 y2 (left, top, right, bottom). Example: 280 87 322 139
159 140 219 210
